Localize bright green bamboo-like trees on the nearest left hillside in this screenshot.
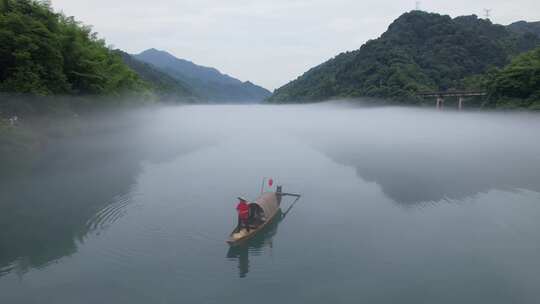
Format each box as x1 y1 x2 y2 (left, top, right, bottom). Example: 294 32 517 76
0 0 144 95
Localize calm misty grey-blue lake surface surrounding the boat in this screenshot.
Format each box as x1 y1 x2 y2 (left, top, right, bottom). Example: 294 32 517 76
0 103 540 303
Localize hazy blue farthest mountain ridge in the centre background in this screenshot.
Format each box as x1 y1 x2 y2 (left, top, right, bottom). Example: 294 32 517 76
134 49 271 103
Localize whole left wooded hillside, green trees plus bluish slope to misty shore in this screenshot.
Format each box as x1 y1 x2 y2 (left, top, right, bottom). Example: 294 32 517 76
0 0 198 119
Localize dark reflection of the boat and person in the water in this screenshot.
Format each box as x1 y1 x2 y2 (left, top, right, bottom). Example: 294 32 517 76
227 211 285 278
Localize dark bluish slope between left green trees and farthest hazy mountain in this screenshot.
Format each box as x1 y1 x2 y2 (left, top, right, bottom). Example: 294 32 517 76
116 50 201 102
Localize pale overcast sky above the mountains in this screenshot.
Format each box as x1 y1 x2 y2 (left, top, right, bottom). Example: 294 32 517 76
52 0 540 90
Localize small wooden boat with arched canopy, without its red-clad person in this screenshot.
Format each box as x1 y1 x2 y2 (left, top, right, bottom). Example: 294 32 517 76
227 191 281 246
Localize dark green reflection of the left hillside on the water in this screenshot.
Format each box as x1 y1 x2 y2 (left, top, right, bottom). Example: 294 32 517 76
0 134 140 273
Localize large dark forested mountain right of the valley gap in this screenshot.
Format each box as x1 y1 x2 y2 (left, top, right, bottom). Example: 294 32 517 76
269 11 540 103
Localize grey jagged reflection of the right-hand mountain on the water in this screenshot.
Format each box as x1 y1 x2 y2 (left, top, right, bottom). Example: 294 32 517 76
320 137 540 205
